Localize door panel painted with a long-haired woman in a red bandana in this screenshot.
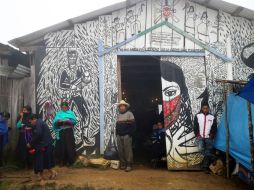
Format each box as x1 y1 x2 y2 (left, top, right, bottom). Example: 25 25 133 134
161 57 206 169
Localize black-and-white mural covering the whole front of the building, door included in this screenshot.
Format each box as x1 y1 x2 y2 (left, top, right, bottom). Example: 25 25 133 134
37 0 254 169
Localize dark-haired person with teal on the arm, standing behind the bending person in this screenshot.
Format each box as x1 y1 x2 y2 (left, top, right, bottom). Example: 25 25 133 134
16 105 32 167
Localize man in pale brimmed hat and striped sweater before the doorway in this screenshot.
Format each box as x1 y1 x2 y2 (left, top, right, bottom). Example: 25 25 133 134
116 100 135 172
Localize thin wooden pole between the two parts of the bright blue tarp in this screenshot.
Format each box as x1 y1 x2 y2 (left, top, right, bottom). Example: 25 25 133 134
223 83 230 178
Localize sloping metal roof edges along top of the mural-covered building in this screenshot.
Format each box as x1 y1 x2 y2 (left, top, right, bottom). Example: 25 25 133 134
9 0 254 48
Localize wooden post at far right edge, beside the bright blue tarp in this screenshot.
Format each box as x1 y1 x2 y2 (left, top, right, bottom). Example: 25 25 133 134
247 101 254 177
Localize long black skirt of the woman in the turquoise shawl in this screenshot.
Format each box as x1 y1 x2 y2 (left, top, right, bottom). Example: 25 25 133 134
55 128 76 165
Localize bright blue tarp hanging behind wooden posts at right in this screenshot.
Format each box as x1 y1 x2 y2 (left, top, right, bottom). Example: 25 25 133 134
214 93 254 171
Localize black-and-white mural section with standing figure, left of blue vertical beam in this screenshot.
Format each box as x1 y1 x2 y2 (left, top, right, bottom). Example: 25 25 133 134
37 22 99 154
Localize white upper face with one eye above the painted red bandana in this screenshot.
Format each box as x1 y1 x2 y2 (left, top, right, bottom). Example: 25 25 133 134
162 78 181 102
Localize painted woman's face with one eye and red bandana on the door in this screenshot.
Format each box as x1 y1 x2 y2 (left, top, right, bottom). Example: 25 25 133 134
162 78 181 127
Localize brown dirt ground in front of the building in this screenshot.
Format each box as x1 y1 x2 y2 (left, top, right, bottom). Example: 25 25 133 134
0 166 251 190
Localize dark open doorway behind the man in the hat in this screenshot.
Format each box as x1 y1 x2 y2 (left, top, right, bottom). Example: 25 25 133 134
119 56 163 163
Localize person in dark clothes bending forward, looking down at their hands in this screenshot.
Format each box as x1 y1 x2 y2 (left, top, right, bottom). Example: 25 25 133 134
27 114 57 182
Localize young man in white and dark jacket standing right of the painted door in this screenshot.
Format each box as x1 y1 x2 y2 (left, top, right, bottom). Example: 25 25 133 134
194 102 217 172
